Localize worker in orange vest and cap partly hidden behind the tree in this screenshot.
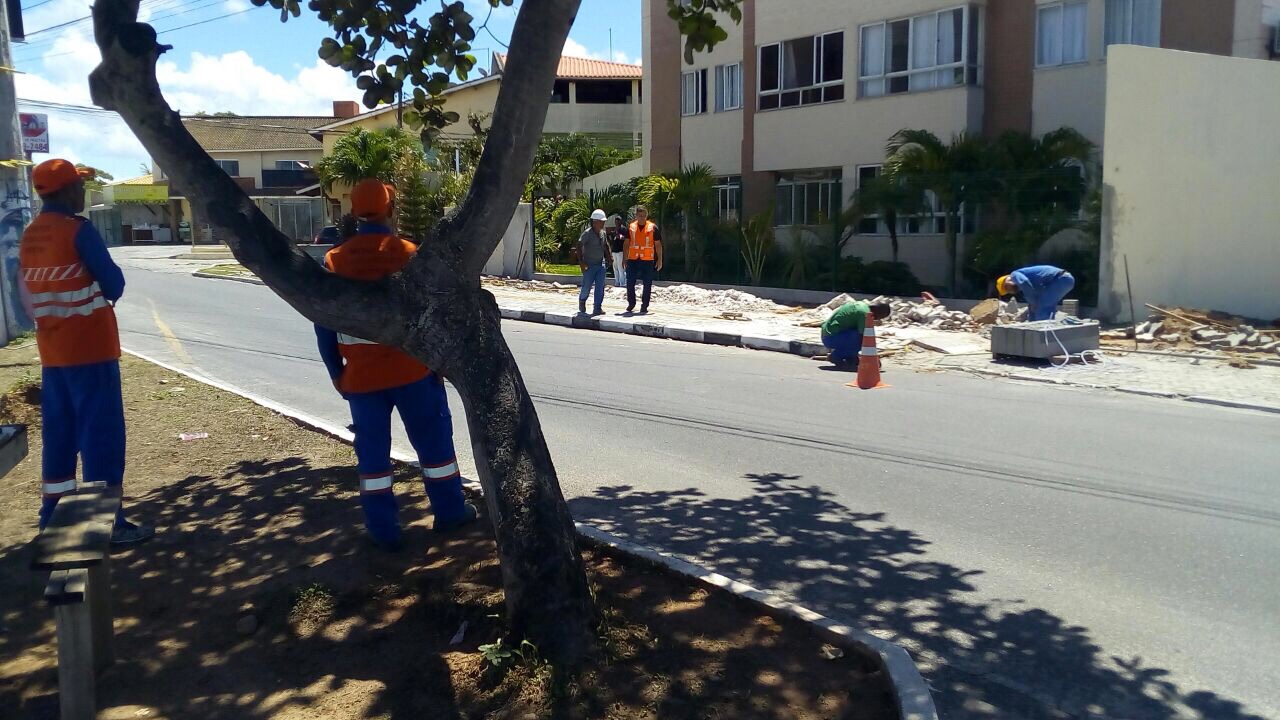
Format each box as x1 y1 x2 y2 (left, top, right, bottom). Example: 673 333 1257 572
316 179 476 550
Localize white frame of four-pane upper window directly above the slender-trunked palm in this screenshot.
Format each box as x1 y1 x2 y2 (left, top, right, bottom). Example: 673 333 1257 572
858 4 984 100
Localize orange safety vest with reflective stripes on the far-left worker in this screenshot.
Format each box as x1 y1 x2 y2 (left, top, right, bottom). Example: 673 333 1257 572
18 213 120 368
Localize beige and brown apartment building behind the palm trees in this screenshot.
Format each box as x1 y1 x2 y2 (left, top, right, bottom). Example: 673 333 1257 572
643 0 1280 284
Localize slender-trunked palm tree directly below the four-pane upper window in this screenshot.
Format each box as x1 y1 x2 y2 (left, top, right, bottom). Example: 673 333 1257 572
884 129 992 295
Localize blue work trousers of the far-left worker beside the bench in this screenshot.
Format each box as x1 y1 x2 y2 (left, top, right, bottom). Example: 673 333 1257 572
40 360 124 529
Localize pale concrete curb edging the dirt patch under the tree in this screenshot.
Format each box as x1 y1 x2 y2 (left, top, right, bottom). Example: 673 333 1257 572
123 345 938 720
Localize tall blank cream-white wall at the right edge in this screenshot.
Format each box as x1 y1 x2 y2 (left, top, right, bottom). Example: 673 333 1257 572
1100 46 1280 319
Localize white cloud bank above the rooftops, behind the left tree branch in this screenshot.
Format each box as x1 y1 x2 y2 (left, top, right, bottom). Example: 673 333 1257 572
14 31 360 178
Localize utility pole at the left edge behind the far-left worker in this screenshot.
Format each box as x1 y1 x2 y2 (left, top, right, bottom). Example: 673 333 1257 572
0 8 31 345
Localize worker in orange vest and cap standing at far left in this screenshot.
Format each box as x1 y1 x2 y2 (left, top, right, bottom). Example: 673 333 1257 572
18 159 155 546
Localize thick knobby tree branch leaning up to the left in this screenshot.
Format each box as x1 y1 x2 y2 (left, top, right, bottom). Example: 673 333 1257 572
90 0 407 345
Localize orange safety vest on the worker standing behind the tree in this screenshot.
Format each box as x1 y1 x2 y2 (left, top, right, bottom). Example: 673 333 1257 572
324 233 431 392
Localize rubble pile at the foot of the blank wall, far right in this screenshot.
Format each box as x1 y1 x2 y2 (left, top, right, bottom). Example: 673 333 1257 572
1102 309 1280 355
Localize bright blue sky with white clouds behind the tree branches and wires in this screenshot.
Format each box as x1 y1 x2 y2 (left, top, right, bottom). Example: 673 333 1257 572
14 0 641 179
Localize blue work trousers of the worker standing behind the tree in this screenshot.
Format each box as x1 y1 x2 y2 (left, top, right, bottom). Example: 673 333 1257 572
347 373 466 547
